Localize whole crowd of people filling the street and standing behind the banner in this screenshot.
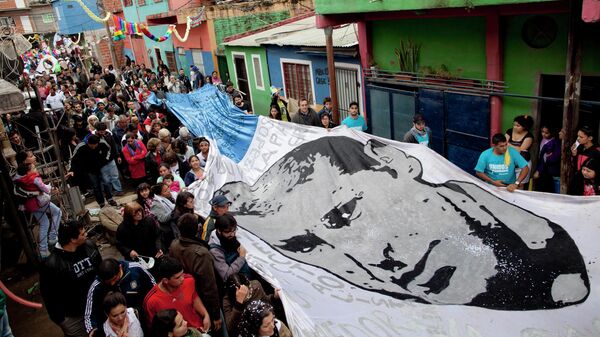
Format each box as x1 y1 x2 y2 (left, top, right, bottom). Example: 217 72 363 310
4 43 600 337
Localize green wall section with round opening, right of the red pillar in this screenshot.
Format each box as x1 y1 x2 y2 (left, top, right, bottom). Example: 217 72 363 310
502 14 600 129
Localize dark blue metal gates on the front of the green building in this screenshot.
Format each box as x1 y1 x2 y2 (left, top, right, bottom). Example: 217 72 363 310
367 85 490 174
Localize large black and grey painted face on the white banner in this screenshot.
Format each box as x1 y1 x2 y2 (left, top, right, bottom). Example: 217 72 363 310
221 137 589 310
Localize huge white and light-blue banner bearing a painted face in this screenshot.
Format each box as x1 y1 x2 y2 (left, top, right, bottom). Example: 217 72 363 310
149 85 600 337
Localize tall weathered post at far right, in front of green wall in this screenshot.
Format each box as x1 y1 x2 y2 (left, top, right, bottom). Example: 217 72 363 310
560 1 582 194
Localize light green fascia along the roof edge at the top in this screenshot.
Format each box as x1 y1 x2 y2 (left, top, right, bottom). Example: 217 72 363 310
315 0 552 14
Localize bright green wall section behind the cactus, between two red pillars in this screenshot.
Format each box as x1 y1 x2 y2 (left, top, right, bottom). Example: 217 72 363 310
370 17 486 78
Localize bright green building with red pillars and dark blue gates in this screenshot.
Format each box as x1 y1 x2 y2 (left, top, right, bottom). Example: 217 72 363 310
315 0 600 172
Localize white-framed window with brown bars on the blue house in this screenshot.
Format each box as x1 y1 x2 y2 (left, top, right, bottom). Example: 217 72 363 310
281 61 314 104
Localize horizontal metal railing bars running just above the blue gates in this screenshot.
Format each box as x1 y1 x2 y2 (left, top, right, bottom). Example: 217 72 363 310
363 68 507 95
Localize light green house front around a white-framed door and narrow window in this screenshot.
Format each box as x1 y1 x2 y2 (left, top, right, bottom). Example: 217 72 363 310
225 46 271 116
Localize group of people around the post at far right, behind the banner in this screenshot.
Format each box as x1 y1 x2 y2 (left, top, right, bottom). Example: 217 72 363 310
475 115 600 196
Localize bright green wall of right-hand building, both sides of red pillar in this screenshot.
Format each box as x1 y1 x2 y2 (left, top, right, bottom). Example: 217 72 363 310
368 14 600 129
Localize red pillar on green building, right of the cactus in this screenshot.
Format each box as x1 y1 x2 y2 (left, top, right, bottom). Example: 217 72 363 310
485 13 503 138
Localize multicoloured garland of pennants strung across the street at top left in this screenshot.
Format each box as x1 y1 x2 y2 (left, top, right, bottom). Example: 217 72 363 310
69 0 205 42
